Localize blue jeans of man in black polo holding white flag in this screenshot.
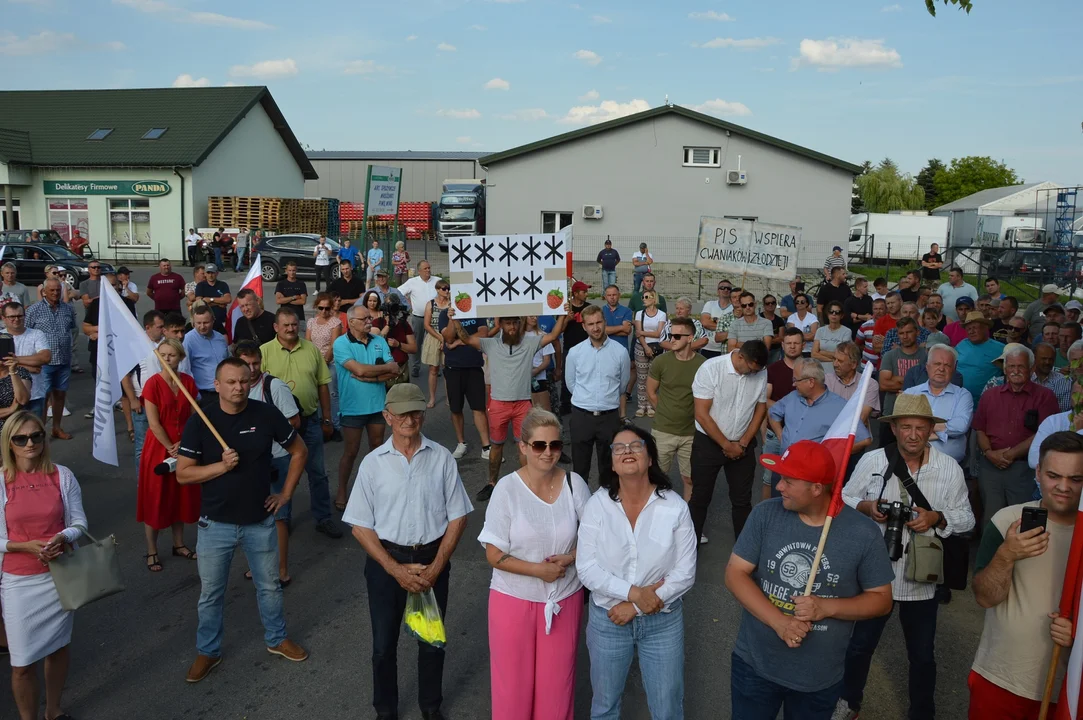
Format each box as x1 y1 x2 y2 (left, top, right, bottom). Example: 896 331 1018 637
196 515 286 657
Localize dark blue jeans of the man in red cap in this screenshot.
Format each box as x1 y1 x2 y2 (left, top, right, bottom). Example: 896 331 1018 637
730 653 843 720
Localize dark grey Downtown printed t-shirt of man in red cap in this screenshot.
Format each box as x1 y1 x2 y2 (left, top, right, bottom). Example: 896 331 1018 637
733 498 895 693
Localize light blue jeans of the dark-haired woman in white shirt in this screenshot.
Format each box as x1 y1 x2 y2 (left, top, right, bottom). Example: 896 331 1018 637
587 600 684 720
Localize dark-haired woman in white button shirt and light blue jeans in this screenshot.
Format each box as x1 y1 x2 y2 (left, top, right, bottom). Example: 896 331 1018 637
575 424 696 720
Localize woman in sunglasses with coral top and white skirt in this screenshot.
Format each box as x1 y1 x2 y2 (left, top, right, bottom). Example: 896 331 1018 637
0 411 87 720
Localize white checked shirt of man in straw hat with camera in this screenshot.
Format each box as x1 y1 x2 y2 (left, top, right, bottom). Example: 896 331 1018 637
843 447 975 601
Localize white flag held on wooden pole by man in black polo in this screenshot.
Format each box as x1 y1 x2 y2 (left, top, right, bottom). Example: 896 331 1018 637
93 283 154 466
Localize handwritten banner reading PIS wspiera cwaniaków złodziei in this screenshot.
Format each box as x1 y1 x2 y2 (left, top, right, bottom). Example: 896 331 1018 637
695 217 801 280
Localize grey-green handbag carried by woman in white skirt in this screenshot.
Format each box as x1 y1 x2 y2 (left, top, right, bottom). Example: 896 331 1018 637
49 525 125 611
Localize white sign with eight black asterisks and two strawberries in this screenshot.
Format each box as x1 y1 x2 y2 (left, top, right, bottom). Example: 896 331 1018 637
447 226 572 318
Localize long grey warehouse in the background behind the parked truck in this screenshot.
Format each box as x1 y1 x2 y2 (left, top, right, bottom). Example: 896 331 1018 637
304 150 485 202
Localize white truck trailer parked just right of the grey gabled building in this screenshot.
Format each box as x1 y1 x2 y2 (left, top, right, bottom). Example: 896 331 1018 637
849 211 948 264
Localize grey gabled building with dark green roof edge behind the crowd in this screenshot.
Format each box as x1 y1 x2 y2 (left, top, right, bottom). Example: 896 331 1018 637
478 105 861 269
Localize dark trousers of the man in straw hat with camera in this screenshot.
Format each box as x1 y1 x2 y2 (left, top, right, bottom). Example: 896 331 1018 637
843 598 940 719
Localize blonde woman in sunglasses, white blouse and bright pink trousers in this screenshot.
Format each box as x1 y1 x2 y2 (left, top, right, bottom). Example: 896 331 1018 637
478 408 590 720
